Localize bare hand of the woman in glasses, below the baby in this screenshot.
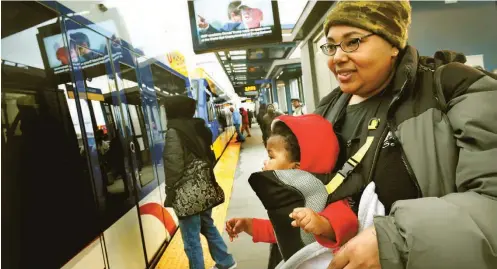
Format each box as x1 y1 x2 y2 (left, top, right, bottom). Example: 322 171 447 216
328 226 381 269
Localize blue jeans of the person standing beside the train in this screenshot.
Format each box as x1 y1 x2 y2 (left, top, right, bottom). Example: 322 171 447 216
179 209 235 269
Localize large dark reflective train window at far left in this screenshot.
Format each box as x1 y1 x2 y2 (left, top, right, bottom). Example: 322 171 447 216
1 1 100 268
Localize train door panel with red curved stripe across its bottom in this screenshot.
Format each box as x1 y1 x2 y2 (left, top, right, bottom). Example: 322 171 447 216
112 43 176 263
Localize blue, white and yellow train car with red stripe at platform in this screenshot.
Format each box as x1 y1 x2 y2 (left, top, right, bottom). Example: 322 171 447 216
1 1 233 269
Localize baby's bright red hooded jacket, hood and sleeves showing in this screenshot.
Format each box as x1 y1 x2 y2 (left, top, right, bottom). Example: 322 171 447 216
252 114 359 248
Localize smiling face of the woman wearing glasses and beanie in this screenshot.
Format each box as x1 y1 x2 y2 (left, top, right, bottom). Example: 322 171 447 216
327 25 399 97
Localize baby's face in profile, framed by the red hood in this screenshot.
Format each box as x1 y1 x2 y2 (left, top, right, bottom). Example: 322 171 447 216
263 135 298 171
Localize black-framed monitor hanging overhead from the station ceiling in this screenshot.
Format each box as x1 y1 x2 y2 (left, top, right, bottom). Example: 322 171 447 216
188 0 282 53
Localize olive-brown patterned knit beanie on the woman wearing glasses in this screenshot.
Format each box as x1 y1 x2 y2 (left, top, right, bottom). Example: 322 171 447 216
324 0 411 49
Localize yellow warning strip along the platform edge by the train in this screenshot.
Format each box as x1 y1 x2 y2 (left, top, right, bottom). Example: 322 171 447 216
156 135 241 269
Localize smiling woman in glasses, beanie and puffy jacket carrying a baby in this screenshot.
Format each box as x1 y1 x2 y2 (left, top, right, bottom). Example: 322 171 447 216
315 1 497 269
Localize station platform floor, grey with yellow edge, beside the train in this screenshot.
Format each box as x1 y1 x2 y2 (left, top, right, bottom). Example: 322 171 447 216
156 123 269 269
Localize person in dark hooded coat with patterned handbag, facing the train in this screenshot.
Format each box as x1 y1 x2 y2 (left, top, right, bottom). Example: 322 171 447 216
164 95 236 269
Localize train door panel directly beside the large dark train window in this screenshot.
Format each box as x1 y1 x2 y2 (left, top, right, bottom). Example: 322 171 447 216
65 19 147 268
